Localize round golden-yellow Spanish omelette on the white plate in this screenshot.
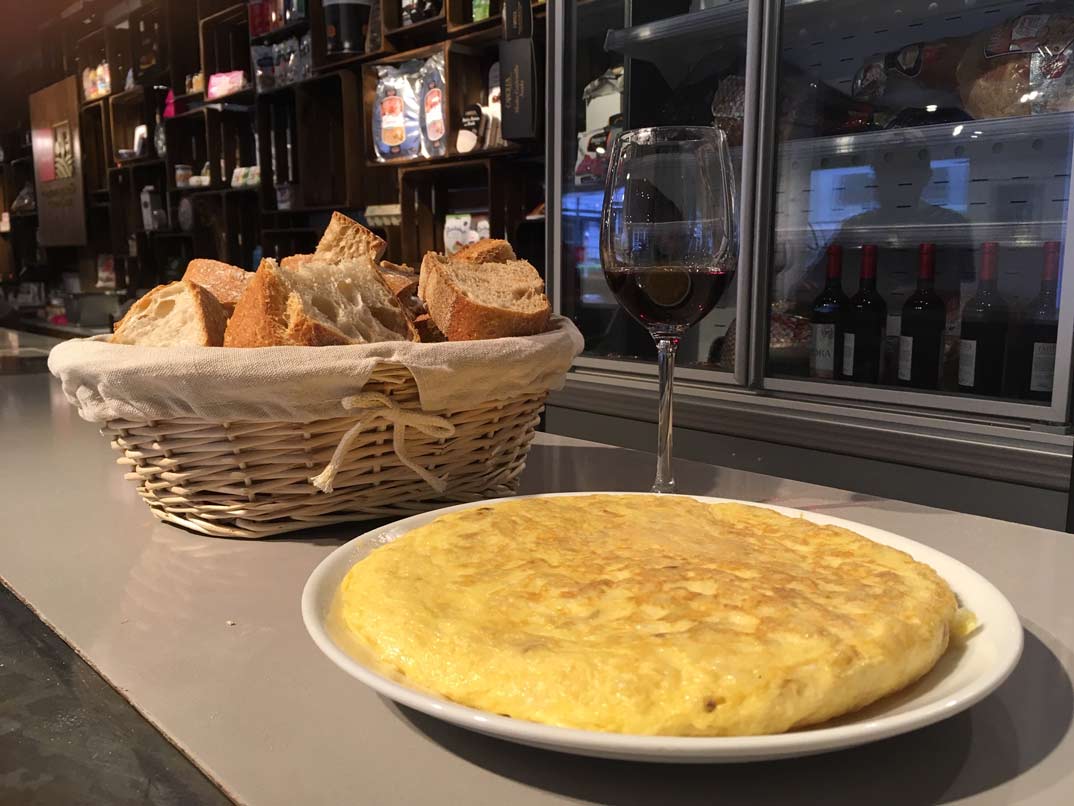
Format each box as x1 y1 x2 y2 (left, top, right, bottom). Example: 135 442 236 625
336 494 970 736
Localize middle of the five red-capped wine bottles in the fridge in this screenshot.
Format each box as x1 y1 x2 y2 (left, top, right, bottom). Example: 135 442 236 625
898 244 946 389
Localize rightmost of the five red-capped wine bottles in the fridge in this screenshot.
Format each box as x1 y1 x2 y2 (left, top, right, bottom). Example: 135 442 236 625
1013 241 1060 401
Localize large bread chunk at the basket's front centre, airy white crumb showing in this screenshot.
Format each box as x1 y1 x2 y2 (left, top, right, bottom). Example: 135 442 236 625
223 258 417 347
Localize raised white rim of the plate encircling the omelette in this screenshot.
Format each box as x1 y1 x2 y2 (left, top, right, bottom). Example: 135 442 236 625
302 490 1025 762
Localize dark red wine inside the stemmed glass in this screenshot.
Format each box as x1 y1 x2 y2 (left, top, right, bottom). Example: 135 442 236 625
605 267 731 335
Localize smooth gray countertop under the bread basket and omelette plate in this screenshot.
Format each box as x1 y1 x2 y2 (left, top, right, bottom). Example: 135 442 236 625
0 374 1074 806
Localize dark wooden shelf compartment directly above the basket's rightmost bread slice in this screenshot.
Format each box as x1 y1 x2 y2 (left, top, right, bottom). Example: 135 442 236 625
399 159 541 267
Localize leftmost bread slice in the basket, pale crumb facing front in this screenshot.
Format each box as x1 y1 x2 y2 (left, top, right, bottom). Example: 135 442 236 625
110 279 228 347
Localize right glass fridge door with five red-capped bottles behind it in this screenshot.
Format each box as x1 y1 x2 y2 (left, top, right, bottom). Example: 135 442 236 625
755 0 1074 423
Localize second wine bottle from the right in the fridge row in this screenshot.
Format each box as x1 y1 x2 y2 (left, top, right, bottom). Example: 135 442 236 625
958 241 1011 395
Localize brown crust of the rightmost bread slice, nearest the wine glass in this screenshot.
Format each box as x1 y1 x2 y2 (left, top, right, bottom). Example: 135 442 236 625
419 253 551 342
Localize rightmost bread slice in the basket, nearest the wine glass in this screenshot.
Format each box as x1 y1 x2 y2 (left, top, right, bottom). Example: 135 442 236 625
418 253 552 342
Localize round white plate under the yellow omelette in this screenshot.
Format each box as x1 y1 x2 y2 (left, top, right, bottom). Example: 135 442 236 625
302 493 1022 763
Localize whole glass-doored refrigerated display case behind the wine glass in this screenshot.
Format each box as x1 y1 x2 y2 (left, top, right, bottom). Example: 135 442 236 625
549 0 1074 517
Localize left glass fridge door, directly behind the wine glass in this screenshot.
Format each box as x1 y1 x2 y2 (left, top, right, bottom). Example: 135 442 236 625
552 0 759 383
